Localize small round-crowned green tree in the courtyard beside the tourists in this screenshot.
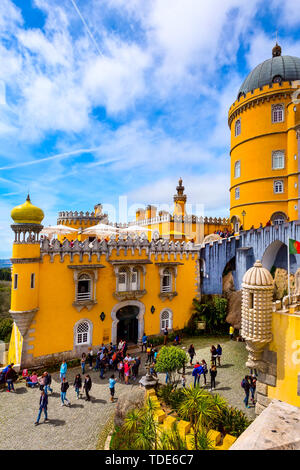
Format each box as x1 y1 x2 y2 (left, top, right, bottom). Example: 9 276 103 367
155 346 187 384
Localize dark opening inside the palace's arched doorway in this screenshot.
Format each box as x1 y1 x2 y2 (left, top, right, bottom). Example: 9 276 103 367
116 305 140 344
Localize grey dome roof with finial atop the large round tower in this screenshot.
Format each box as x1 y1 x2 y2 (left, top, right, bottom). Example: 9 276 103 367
238 43 300 98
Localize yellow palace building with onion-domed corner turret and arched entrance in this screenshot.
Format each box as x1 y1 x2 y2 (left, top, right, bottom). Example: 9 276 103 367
8 181 228 367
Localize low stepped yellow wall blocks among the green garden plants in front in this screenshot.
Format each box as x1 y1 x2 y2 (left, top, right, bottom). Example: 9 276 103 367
146 389 237 450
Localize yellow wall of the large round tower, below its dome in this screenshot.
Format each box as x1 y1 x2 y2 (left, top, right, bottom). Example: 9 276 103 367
229 82 300 229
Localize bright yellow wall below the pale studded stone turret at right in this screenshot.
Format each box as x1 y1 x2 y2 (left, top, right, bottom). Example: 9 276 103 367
268 312 300 407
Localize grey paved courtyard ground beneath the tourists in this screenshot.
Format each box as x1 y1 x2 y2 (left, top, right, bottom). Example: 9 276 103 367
0 338 254 450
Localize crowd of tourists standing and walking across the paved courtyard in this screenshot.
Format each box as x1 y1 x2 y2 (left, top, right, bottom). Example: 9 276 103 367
1 329 256 425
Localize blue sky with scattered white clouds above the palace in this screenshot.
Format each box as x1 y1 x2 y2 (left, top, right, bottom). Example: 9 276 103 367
0 0 300 257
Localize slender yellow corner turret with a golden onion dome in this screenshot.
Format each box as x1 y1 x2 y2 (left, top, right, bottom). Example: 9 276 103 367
9 195 44 366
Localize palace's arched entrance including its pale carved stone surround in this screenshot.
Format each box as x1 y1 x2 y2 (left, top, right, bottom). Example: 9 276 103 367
111 300 145 344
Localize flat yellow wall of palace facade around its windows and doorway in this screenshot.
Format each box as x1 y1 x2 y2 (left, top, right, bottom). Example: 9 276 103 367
17 251 197 357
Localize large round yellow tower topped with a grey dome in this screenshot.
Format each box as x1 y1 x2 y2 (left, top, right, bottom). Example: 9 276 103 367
228 44 300 231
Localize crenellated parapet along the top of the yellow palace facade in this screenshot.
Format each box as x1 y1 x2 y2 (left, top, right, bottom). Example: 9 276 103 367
41 236 198 262
